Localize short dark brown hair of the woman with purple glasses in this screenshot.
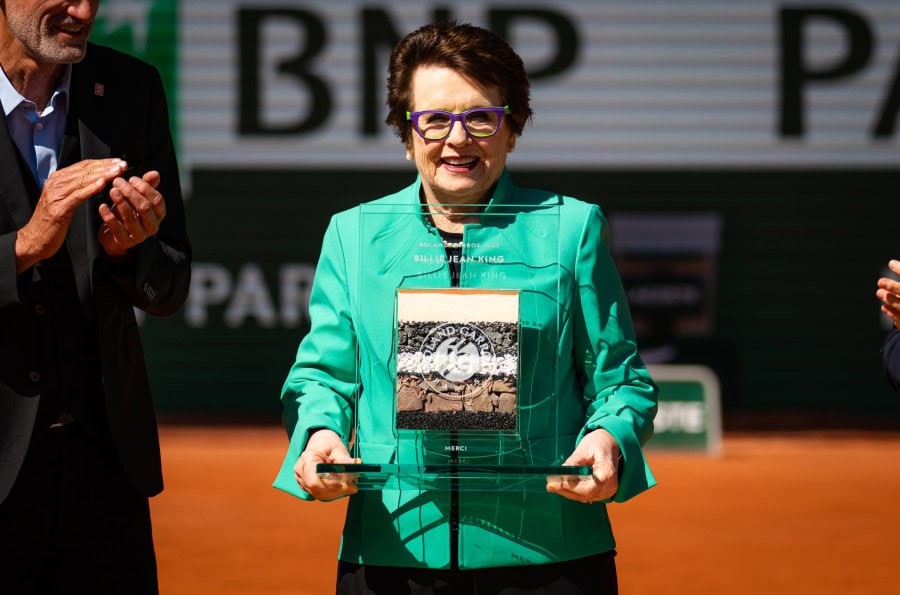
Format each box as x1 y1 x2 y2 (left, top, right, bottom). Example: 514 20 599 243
385 21 531 143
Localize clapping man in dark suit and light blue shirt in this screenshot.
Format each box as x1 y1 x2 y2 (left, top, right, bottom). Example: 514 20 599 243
0 0 191 594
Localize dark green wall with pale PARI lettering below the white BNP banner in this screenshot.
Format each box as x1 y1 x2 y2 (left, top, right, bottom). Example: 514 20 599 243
132 166 900 416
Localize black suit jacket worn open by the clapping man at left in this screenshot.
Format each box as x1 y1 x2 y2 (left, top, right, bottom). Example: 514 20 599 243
0 44 191 502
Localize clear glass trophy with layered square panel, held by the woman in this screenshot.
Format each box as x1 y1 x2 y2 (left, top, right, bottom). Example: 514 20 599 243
317 201 591 491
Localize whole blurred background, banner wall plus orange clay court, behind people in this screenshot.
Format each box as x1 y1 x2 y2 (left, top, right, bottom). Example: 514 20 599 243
81 0 900 595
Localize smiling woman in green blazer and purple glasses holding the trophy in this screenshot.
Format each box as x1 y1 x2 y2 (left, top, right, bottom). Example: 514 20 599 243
275 23 656 594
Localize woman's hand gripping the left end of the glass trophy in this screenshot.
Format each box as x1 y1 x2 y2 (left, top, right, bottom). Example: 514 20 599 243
294 428 362 501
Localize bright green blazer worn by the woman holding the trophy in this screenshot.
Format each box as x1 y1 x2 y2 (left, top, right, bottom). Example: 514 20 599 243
275 171 657 568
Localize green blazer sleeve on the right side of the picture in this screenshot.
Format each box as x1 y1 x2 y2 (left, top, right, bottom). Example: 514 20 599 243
573 206 657 502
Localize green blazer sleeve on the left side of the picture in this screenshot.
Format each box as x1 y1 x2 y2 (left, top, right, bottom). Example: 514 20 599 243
275 218 359 500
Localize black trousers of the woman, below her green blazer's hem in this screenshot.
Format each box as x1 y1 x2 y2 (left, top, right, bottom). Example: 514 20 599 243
337 551 619 595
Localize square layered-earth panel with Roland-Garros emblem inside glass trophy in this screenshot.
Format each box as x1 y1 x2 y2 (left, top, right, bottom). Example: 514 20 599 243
396 289 519 432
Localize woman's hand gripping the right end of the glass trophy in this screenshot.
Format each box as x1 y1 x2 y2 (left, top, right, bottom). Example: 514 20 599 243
547 428 619 504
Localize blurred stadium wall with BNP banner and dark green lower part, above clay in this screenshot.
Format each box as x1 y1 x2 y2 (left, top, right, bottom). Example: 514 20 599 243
93 0 900 429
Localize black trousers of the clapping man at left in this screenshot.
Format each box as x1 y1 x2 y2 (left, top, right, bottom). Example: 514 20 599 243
0 423 159 595
